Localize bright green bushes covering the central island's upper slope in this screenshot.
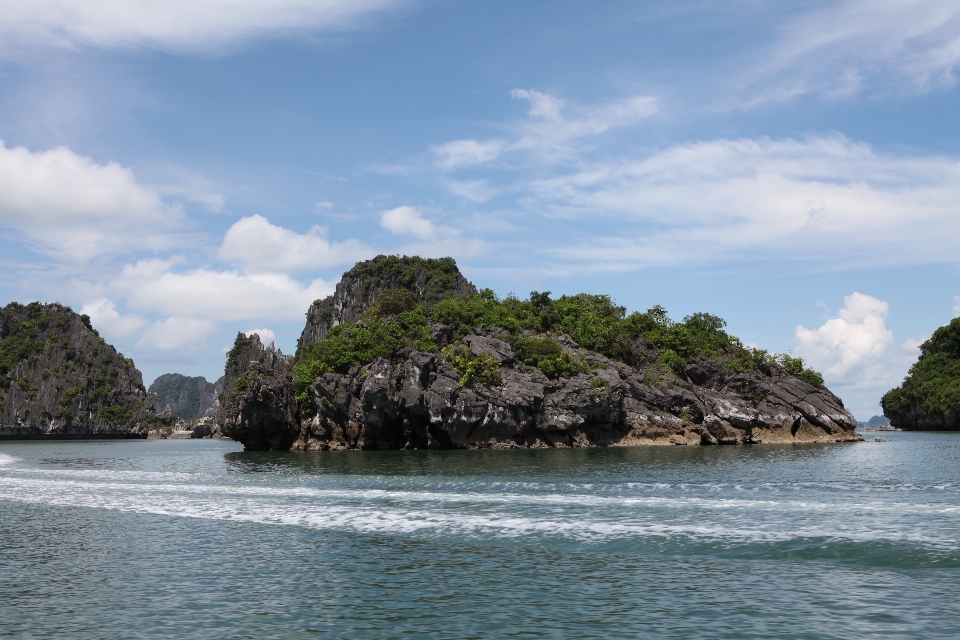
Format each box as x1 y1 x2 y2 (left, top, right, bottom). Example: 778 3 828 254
293 290 823 416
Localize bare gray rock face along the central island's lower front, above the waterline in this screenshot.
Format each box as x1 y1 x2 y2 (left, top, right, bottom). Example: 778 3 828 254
291 336 862 450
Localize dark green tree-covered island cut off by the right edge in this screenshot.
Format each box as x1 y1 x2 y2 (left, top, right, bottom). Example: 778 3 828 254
880 318 960 431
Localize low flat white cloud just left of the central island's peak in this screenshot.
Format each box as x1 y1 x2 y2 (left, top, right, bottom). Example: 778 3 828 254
108 260 333 322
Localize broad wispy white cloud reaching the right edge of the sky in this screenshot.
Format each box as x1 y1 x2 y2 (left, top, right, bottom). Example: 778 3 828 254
522 135 960 266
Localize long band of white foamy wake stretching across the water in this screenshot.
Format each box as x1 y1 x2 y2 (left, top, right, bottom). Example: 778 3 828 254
0 473 960 549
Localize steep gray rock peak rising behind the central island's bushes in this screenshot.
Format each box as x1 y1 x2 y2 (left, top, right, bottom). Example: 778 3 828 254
297 256 477 349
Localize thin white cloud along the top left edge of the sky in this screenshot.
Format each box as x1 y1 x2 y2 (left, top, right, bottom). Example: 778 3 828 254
0 0 399 55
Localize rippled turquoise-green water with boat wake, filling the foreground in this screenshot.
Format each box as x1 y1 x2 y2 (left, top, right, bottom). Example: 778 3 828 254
0 433 960 638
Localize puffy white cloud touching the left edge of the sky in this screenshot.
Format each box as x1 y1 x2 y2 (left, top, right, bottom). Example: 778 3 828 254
0 141 190 261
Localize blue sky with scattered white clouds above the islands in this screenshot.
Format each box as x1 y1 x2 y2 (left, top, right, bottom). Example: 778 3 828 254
0 0 960 420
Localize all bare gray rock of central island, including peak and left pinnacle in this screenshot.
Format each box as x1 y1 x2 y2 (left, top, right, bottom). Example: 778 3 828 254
217 256 862 451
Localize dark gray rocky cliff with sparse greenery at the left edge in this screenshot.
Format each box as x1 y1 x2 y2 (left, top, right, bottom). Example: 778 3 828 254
0 302 156 439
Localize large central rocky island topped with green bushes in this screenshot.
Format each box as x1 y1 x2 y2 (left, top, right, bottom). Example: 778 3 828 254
217 256 862 451
